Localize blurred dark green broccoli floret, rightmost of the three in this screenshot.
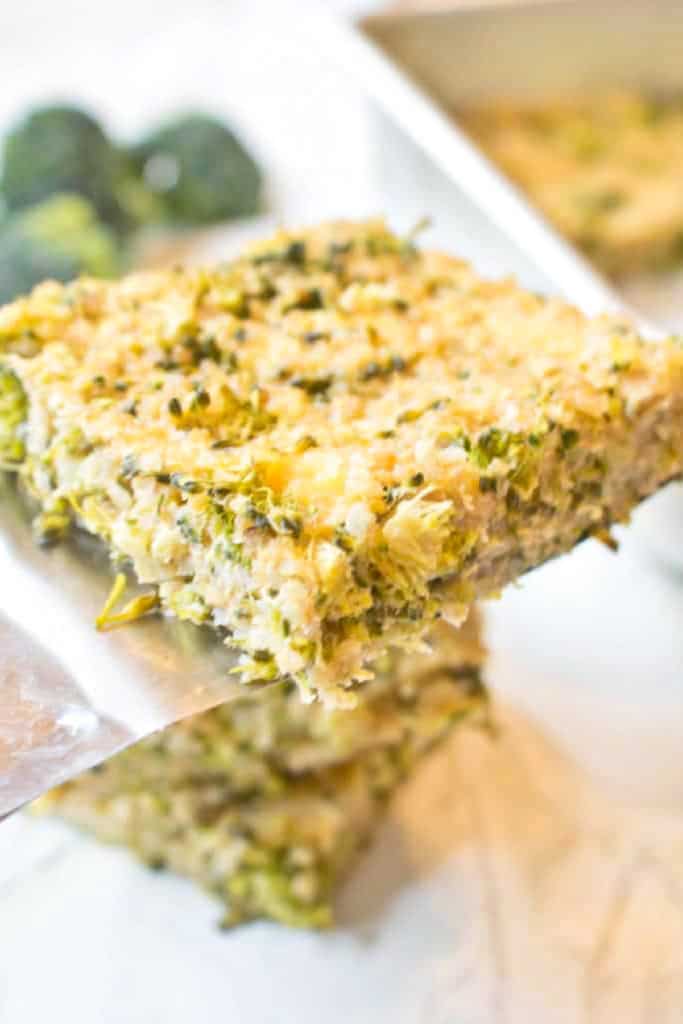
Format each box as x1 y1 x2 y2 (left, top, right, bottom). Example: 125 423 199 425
131 114 261 224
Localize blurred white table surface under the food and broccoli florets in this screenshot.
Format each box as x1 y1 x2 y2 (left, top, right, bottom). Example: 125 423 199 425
0 0 683 1024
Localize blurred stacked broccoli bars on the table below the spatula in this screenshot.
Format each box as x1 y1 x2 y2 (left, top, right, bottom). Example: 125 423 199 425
36 616 486 927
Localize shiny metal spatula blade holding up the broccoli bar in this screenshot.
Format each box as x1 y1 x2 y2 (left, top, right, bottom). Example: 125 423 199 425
0 474 241 818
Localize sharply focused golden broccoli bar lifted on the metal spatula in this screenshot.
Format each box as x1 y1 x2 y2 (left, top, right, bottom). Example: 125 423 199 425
0 222 683 706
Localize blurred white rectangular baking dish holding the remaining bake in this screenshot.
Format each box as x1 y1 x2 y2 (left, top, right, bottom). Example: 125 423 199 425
327 0 683 570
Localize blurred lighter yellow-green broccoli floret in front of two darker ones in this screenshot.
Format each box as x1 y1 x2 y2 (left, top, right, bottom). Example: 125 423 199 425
0 196 122 302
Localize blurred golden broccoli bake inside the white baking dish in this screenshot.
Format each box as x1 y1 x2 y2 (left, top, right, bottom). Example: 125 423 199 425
459 91 683 275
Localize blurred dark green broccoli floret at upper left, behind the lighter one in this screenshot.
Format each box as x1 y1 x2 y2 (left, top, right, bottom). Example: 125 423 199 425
0 105 130 230
